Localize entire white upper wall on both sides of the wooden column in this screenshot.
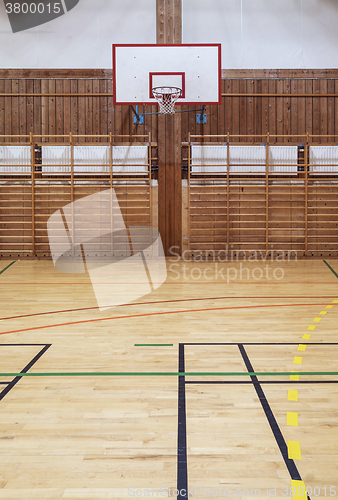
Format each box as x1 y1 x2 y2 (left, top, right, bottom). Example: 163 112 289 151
0 0 338 69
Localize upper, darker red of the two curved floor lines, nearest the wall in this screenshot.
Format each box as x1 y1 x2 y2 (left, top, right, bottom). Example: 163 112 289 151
0 294 337 321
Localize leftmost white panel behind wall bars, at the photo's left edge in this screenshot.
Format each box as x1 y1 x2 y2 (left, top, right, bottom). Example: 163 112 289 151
0 146 31 174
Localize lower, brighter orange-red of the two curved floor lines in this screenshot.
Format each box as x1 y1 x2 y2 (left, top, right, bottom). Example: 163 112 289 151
0 302 327 335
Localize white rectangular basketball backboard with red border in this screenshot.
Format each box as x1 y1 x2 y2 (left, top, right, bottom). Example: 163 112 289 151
113 43 221 104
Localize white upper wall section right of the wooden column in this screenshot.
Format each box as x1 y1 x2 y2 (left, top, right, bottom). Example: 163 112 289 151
183 0 338 69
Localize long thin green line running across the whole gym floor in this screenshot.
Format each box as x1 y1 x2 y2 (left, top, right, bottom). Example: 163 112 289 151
0 372 338 377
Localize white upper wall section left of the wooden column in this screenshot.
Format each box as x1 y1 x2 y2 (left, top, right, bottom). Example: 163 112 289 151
0 0 156 68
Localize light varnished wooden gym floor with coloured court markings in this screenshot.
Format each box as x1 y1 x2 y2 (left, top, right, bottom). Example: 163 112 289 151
0 260 338 500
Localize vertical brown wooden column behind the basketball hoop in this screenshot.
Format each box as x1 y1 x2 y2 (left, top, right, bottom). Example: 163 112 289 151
156 0 182 256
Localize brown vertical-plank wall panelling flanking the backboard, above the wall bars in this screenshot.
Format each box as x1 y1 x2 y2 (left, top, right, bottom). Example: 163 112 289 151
0 69 338 142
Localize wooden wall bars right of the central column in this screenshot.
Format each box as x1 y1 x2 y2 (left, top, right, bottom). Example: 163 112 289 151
184 134 338 257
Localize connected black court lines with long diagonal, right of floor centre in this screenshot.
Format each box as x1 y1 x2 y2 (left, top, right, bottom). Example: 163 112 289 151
177 342 338 500
